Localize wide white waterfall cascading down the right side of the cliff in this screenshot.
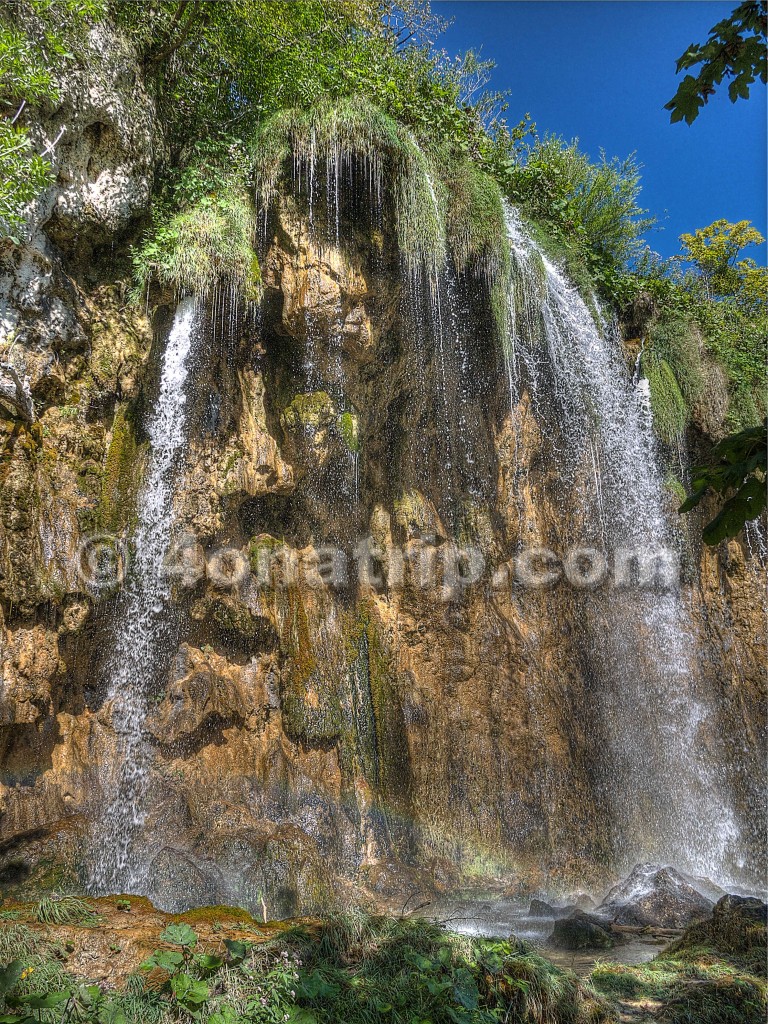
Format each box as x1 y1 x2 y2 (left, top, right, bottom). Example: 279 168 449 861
507 203 739 882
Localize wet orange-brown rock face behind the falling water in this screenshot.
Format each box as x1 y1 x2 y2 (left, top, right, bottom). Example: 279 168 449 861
0 16 764 927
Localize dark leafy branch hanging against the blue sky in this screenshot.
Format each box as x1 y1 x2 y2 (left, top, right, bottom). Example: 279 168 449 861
665 0 768 125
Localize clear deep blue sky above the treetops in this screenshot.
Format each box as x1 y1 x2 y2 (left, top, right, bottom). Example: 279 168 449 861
432 0 767 261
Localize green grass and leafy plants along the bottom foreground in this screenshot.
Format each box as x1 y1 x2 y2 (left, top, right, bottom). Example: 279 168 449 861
0 913 613 1024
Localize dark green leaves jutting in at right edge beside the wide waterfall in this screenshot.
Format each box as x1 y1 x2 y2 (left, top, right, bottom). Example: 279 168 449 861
680 421 768 545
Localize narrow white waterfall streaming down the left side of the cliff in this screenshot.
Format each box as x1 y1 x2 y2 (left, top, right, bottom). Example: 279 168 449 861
90 298 201 894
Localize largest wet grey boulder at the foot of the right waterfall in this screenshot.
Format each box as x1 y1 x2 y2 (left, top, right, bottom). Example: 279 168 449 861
598 864 713 929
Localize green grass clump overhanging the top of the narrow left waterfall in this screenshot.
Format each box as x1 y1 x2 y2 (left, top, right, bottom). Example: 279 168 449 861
133 186 261 301
